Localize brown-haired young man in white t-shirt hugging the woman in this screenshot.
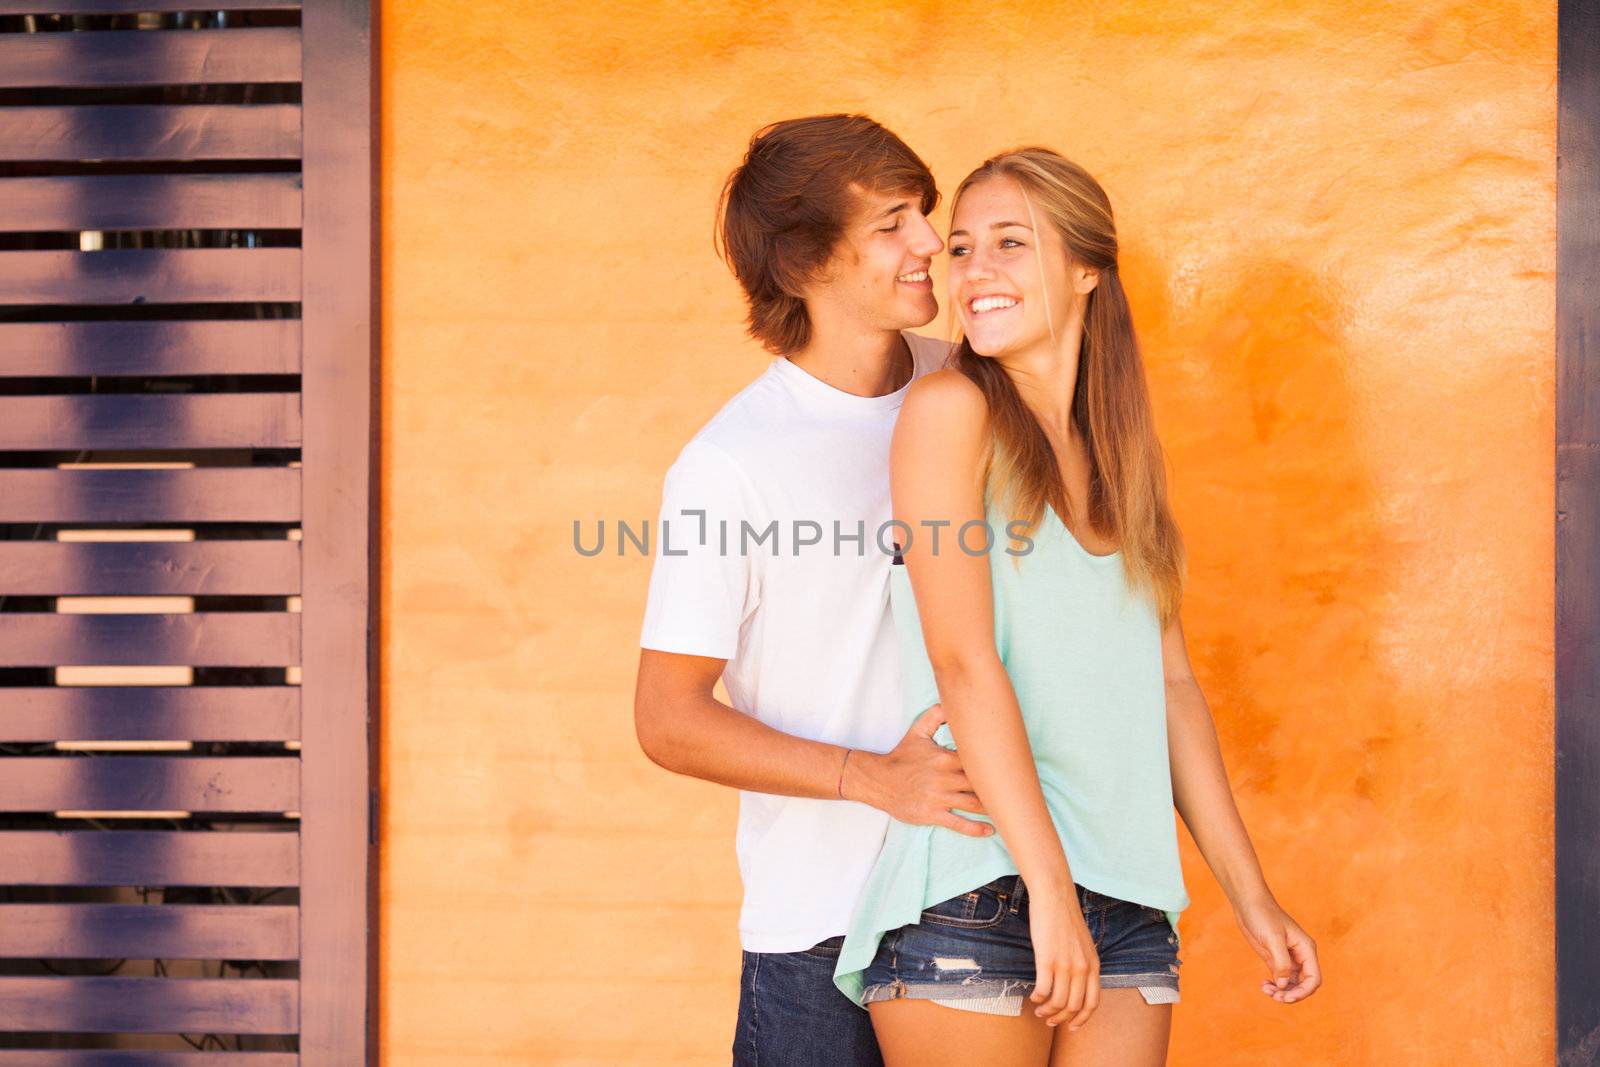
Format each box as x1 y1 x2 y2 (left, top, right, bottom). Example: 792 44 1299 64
635 115 994 1067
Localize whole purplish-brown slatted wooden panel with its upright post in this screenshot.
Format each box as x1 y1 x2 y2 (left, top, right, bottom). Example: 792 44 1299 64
0 0 374 1067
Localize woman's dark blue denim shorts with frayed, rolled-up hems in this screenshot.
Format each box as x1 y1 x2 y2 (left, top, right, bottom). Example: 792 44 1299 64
862 875 1182 1016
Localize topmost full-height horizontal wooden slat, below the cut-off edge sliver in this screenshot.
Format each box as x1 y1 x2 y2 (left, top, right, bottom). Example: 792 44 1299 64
0 27 301 88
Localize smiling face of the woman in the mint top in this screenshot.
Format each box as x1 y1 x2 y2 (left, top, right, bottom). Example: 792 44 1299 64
950 176 1088 357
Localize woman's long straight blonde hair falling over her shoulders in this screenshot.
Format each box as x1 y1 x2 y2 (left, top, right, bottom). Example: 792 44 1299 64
952 147 1184 629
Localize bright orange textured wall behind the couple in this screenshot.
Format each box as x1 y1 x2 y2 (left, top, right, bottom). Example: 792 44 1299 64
382 0 1555 1067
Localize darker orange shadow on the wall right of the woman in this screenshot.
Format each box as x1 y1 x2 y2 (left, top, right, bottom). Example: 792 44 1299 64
1125 253 1401 1054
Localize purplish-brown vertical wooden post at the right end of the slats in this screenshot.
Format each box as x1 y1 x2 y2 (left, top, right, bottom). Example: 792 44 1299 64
299 0 379 1067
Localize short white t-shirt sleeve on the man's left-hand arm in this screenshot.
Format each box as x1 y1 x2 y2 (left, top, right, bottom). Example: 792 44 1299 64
638 440 757 659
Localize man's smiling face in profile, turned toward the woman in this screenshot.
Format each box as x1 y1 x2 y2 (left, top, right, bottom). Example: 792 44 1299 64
806 187 944 330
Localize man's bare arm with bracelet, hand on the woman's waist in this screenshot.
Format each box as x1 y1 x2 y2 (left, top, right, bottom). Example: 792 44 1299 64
634 648 994 837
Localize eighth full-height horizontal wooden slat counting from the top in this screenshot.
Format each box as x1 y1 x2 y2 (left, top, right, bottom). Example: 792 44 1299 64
0 541 301 591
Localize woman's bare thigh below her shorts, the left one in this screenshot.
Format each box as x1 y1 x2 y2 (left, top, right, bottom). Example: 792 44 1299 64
867 990 1056 1067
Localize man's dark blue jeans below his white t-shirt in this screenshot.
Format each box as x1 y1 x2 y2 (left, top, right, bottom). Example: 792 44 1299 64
733 934 883 1067
